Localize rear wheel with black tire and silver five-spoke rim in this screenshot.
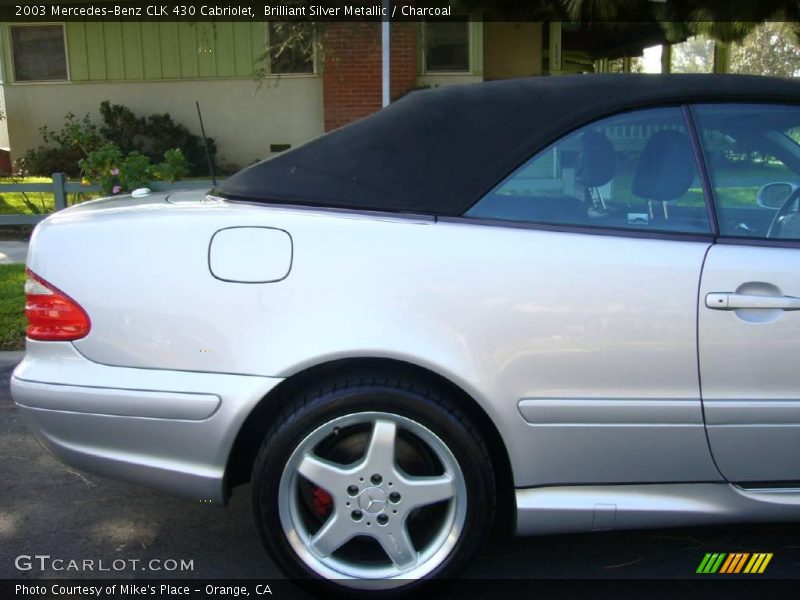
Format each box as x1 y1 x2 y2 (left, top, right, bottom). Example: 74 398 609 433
252 377 496 595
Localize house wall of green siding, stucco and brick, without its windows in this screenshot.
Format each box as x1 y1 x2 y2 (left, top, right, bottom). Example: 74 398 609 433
0 20 544 167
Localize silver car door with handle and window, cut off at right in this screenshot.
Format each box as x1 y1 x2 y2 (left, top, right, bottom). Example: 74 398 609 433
693 104 800 485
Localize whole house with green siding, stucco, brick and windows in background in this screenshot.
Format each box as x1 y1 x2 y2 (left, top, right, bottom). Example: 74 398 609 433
0 15 684 171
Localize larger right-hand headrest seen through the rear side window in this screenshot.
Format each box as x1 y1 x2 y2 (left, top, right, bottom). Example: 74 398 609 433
632 130 697 202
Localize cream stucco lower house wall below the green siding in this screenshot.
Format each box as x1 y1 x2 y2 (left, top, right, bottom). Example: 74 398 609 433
5 77 323 167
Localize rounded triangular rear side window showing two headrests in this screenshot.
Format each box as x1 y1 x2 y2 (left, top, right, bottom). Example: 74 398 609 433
466 107 711 233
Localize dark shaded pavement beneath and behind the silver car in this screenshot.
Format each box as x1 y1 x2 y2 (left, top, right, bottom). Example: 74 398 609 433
0 353 800 598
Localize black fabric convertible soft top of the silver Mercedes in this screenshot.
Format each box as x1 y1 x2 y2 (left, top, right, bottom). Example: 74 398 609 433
215 74 800 216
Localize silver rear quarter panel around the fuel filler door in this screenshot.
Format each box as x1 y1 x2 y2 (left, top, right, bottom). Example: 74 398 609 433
30 202 718 486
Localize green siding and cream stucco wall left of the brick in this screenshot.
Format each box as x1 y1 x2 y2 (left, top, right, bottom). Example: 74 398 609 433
0 22 323 166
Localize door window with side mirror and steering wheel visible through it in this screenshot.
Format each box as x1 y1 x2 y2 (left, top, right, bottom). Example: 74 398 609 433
693 104 800 240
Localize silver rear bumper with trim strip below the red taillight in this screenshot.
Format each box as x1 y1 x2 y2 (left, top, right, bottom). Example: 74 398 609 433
11 340 282 502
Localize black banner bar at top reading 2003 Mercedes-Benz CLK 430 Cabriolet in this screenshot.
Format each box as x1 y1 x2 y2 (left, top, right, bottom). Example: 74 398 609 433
0 0 800 23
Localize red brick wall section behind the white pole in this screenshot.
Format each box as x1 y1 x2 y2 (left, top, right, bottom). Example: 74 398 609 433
322 23 417 131
